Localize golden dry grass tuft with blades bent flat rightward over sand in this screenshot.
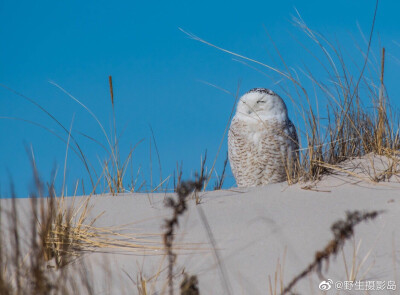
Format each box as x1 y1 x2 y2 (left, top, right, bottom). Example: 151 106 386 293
32 169 166 269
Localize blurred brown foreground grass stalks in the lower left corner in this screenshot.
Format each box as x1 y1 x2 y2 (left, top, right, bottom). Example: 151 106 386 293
0 184 93 295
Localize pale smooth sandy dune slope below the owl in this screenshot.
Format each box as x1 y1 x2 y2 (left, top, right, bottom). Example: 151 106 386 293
3 160 400 295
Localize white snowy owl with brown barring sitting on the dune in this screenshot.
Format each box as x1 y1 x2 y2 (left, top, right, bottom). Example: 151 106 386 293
228 88 299 187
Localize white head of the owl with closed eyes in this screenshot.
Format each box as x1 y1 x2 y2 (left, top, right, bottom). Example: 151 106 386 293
236 88 287 121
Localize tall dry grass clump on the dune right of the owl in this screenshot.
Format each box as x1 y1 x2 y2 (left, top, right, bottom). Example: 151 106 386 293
182 3 400 184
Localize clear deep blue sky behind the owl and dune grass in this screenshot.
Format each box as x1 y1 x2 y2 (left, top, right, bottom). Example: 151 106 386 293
0 0 400 197
